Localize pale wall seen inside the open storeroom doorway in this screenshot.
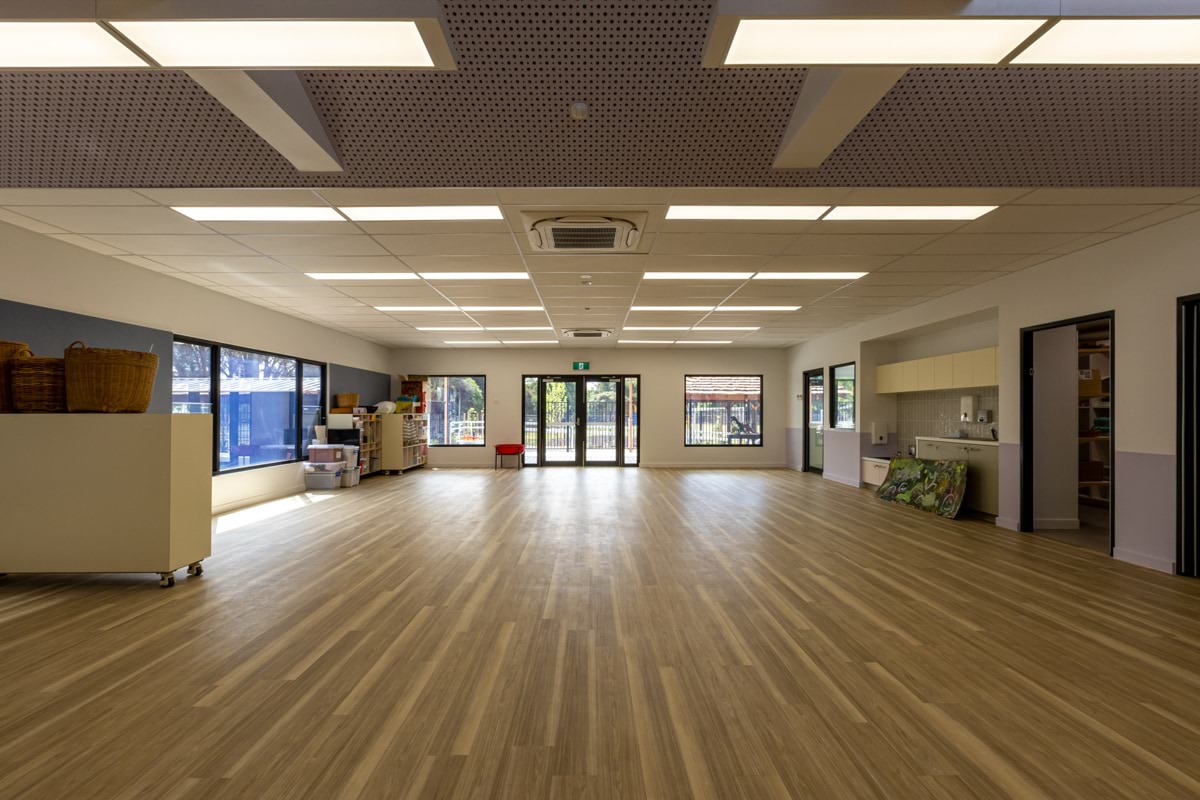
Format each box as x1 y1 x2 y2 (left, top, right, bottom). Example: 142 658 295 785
1033 325 1079 530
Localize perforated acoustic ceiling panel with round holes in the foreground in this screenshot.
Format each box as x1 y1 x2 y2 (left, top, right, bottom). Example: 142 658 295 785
0 0 1200 187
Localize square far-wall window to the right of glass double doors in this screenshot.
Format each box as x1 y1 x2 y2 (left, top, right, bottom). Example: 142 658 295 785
683 375 762 447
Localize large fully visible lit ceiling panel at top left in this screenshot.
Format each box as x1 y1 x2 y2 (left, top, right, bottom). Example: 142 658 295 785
110 19 433 68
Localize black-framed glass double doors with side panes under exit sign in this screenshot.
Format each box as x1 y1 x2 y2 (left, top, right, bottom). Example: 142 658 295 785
522 375 640 467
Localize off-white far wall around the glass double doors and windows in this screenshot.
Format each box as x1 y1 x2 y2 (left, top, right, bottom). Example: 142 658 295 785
392 347 787 467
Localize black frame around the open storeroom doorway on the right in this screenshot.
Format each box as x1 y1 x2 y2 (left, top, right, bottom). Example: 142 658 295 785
1019 311 1117 555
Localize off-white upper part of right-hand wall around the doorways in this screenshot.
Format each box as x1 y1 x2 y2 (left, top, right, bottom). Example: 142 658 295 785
787 209 1200 570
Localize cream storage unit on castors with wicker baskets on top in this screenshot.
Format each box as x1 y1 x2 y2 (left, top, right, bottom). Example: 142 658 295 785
0 414 212 587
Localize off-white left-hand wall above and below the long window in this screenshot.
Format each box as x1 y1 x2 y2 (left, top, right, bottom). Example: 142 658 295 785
0 223 391 511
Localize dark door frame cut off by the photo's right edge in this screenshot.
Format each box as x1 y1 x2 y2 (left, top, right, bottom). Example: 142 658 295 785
1175 294 1200 578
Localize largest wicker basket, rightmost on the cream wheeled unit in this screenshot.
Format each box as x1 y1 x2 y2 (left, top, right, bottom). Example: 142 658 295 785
64 342 158 414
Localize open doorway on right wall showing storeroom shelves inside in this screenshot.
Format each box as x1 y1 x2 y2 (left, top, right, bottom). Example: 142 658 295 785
1021 312 1115 555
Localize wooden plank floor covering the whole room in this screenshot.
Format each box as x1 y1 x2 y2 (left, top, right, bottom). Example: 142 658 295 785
0 469 1200 800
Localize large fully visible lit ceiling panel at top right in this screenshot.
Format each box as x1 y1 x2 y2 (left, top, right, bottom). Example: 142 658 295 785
725 18 1045 66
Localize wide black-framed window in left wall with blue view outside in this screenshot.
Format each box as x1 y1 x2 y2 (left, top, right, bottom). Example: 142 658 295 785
172 339 325 473
